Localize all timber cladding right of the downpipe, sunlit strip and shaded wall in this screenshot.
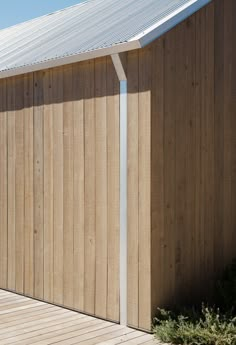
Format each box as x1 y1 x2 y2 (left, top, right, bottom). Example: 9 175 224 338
127 0 236 329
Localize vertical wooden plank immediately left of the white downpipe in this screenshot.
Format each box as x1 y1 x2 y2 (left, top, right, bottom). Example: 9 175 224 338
107 57 120 321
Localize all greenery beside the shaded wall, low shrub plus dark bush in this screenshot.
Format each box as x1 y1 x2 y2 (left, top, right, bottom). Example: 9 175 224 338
153 260 236 345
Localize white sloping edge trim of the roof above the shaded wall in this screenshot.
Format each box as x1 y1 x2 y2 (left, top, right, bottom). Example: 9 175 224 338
130 0 212 48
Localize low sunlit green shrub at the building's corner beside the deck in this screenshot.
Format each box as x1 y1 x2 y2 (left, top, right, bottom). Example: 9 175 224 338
153 306 236 345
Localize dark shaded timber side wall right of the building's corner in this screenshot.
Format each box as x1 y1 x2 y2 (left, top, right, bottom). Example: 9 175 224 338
149 0 236 320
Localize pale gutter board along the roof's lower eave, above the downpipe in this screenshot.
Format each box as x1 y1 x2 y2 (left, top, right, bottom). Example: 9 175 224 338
0 40 141 79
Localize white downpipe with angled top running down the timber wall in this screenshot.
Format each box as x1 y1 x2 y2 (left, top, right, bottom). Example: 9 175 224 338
111 54 128 326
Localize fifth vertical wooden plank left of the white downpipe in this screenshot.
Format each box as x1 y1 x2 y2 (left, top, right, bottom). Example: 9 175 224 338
63 66 74 307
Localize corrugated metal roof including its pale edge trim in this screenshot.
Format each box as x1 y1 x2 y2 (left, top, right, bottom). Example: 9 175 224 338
0 0 211 78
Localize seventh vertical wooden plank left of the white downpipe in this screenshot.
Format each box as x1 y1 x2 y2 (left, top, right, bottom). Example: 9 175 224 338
43 70 54 302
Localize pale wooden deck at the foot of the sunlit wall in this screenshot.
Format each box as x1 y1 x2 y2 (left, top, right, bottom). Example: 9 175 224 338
0 290 159 345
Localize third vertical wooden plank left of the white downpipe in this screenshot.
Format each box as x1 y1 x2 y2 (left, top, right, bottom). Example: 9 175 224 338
84 60 96 314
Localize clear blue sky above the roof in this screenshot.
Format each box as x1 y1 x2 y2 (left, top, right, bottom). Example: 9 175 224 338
0 0 82 29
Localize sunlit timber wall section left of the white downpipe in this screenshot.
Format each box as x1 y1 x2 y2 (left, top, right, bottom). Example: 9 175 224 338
0 58 119 321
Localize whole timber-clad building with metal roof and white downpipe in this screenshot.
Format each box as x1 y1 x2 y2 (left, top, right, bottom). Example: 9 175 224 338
0 0 236 330
